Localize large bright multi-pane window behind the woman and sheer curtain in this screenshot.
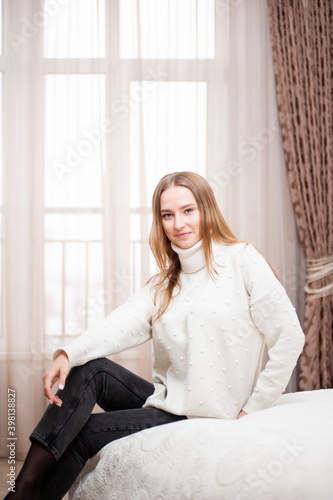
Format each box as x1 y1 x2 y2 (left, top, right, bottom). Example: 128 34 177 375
44 0 211 350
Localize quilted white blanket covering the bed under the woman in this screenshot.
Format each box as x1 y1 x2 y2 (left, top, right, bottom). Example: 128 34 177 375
69 389 333 500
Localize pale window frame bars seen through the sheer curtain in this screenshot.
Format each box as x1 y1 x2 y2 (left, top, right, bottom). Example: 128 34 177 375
0 0 226 368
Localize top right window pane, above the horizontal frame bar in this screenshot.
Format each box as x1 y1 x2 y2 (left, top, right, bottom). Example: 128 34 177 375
120 0 215 59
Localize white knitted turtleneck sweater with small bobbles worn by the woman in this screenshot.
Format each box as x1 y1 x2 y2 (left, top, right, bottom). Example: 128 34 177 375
54 241 304 419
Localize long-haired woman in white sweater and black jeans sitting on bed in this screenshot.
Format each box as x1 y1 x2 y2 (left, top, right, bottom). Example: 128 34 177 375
6 172 304 500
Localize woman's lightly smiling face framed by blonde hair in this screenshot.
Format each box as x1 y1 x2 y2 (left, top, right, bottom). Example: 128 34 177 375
160 186 201 248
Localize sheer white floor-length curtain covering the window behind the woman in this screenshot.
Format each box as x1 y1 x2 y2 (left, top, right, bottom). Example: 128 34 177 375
0 0 302 458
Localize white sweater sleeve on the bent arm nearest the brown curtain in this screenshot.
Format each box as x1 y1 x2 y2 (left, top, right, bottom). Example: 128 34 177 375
237 245 304 413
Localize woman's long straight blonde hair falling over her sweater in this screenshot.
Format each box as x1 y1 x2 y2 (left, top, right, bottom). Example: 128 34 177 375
149 172 241 320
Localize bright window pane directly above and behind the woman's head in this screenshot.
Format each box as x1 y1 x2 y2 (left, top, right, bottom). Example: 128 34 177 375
130 81 207 208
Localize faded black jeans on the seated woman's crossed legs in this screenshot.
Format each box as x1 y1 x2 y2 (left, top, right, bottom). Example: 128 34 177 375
30 358 186 500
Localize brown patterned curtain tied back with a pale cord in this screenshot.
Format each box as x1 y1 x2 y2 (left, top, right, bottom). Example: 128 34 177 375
268 0 333 390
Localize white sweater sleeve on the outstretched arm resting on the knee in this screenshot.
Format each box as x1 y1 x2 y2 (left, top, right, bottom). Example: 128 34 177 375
53 284 154 368
